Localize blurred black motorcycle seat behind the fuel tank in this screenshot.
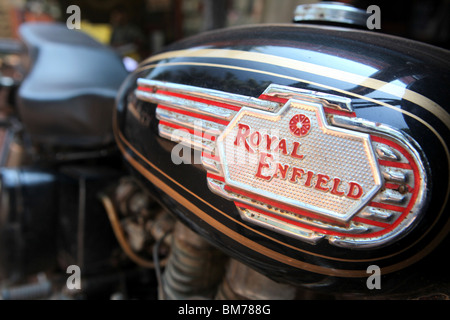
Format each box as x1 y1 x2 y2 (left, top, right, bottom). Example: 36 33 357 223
18 23 127 148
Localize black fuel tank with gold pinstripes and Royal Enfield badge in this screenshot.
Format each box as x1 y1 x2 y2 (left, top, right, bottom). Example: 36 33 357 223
113 25 450 292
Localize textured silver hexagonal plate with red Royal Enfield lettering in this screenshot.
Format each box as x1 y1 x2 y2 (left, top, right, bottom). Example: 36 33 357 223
217 100 381 224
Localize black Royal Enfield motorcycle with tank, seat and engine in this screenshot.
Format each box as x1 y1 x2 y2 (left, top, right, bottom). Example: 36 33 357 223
0 1 450 300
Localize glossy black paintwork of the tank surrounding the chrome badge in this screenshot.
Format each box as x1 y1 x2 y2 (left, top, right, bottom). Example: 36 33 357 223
116 25 450 294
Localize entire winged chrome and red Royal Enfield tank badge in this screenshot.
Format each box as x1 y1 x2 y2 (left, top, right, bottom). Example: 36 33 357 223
136 79 427 248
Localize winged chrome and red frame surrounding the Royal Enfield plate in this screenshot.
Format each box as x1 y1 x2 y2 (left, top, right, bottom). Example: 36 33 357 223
136 79 428 249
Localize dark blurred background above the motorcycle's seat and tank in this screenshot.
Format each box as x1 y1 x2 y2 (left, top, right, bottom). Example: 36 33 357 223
0 0 450 60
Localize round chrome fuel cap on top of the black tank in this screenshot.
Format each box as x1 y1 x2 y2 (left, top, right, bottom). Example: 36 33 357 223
294 1 369 26
